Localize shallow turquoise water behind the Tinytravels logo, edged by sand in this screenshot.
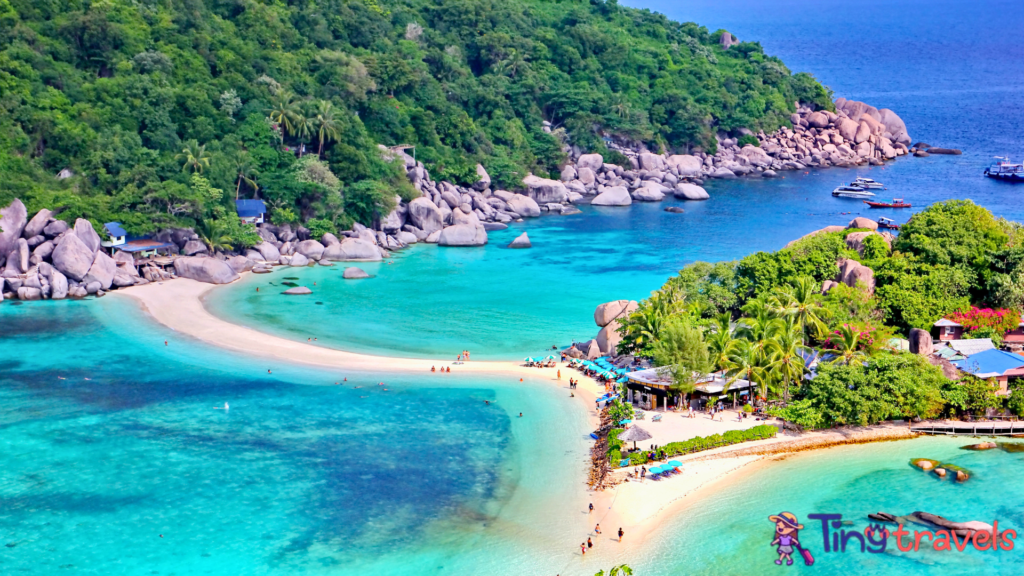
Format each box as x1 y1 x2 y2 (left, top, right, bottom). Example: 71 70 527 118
631 438 1024 575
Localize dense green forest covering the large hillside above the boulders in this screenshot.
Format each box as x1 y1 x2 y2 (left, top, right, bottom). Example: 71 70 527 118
0 0 831 239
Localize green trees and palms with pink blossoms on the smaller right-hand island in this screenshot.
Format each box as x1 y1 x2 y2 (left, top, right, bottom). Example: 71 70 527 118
618 200 1024 427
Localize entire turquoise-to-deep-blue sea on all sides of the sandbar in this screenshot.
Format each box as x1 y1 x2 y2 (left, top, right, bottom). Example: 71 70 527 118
0 0 1024 576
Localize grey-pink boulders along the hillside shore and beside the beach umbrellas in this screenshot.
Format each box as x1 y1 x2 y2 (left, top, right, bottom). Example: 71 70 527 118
0 98 925 303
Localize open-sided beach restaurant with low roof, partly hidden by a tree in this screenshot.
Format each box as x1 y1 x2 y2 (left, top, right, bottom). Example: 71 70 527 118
626 367 751 410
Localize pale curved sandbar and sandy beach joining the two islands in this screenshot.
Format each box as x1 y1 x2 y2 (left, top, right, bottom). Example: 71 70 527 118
116 279 914 557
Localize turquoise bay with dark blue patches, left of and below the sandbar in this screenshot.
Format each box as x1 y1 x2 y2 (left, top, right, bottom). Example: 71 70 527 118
0 298 588 574
